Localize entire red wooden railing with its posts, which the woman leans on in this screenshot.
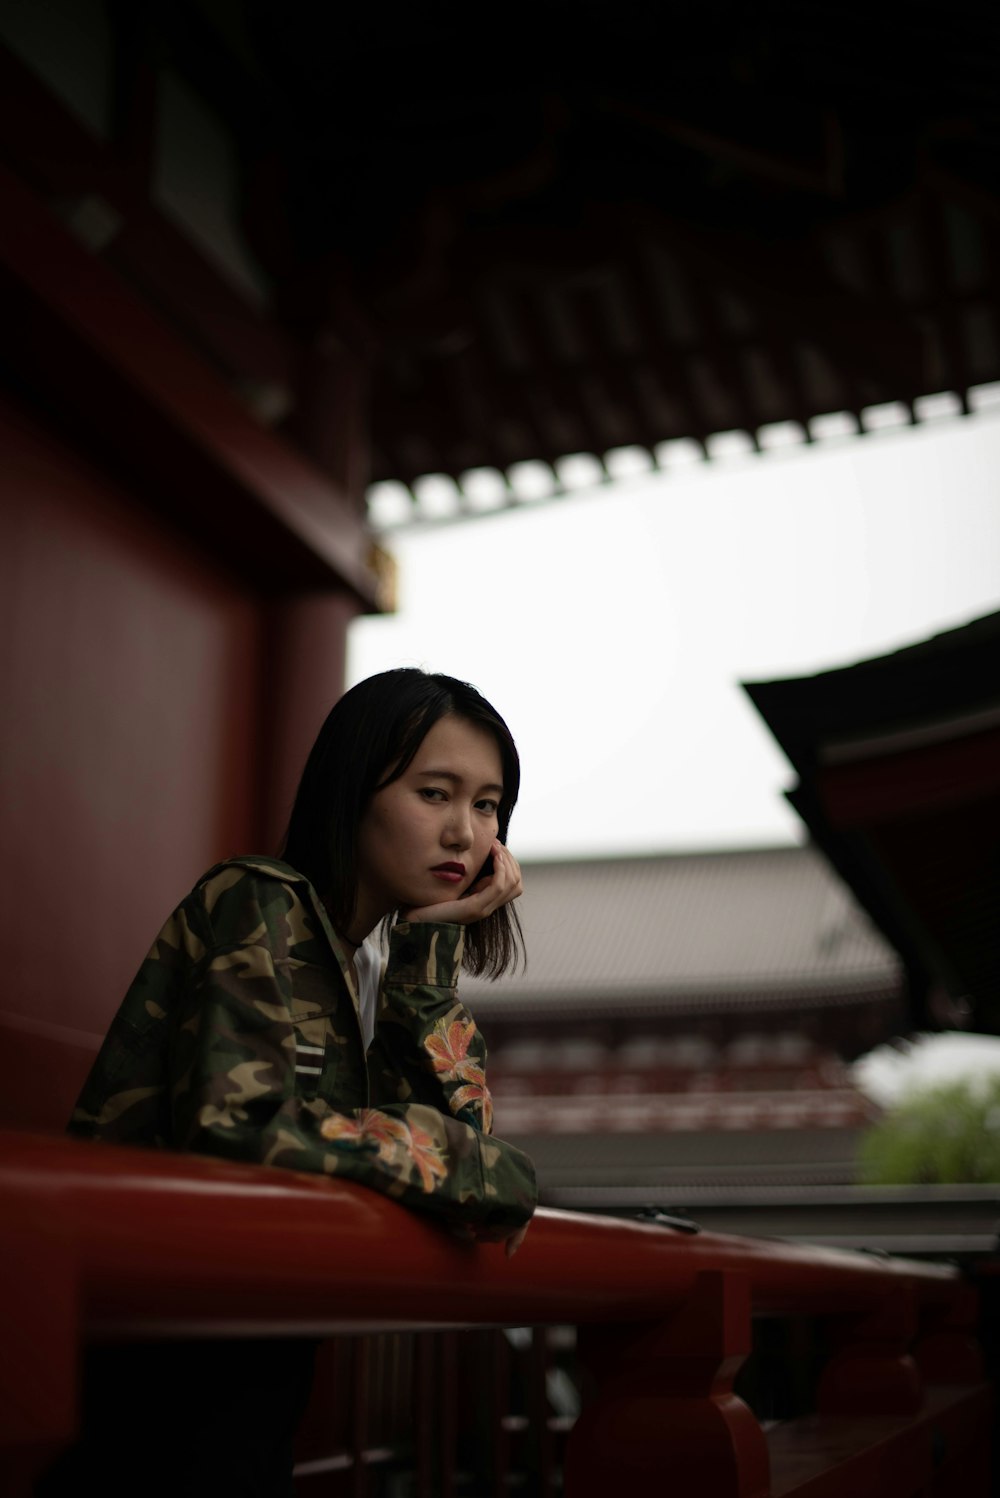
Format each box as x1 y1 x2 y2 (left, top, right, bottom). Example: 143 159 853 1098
0 1134 990 1498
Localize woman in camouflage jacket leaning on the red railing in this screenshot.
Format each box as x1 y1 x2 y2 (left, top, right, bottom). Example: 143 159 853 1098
52 670 536 1498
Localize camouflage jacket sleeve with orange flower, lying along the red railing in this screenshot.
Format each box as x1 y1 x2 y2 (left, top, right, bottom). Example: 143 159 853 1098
169 881 536 1231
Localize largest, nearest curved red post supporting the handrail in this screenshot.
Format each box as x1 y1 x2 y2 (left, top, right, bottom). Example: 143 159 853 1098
566 1270 769 1498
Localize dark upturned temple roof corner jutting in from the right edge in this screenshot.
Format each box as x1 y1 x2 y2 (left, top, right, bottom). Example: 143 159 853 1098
747 614 1000 1034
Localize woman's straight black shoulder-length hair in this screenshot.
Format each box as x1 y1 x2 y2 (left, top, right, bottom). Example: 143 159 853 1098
281 668 524 978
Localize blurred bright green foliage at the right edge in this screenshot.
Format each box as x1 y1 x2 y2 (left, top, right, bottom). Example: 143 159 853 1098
861 1077 1000 1186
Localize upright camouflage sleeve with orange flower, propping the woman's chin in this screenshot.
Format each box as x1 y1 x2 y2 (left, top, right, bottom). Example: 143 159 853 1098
368 921 493 1134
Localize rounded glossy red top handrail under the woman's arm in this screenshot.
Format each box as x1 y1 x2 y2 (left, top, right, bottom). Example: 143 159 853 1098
0 1132 958 1336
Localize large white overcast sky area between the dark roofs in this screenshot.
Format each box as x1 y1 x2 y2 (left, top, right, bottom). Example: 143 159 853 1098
349 409 1000 858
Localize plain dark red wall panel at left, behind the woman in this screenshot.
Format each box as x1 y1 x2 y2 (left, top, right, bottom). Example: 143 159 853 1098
0 394 263 1060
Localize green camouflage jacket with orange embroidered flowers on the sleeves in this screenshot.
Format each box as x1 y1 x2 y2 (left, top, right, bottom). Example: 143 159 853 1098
69 857 536 1233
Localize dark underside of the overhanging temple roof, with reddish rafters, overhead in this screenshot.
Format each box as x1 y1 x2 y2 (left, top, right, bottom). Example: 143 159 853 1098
175 0 1000 497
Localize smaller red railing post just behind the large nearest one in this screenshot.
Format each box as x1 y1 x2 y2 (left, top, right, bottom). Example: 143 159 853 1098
817 1284 924 1414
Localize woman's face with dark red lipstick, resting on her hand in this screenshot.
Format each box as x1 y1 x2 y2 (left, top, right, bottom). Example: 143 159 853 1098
356 715 503 926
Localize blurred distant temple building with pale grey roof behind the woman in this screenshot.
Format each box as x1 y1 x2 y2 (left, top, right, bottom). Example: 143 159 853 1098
463 848 904 1206
